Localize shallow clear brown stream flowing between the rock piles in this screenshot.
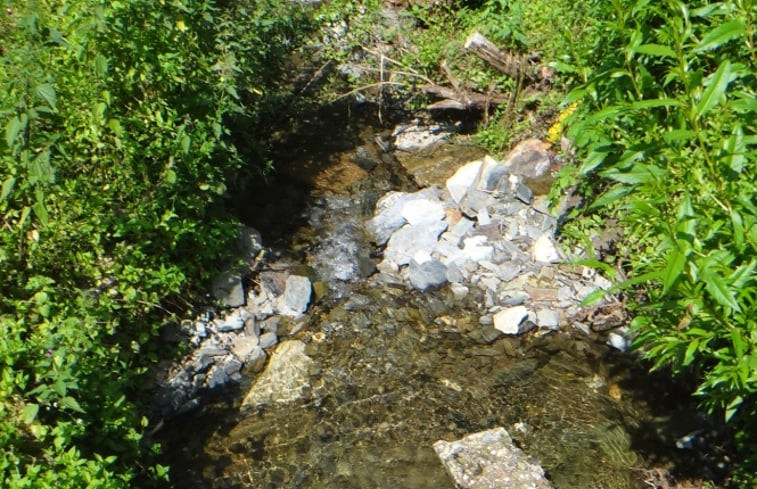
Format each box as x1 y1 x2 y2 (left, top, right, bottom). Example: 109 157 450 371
159 105 724 489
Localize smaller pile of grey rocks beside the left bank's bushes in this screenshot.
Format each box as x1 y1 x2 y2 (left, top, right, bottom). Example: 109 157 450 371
153 228 312 418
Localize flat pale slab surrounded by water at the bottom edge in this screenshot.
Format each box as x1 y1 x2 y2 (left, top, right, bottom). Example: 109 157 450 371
434 428 552 489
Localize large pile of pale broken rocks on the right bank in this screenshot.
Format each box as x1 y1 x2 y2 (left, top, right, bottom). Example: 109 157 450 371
367 155 611 335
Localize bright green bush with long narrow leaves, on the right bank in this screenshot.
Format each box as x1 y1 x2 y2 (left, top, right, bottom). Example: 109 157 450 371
569 0 757 480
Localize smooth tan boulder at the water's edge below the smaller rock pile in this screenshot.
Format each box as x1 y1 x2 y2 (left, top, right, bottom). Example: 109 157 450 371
242 340 313 407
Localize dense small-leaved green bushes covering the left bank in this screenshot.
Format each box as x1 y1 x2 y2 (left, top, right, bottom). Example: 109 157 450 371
0 0 307 488
